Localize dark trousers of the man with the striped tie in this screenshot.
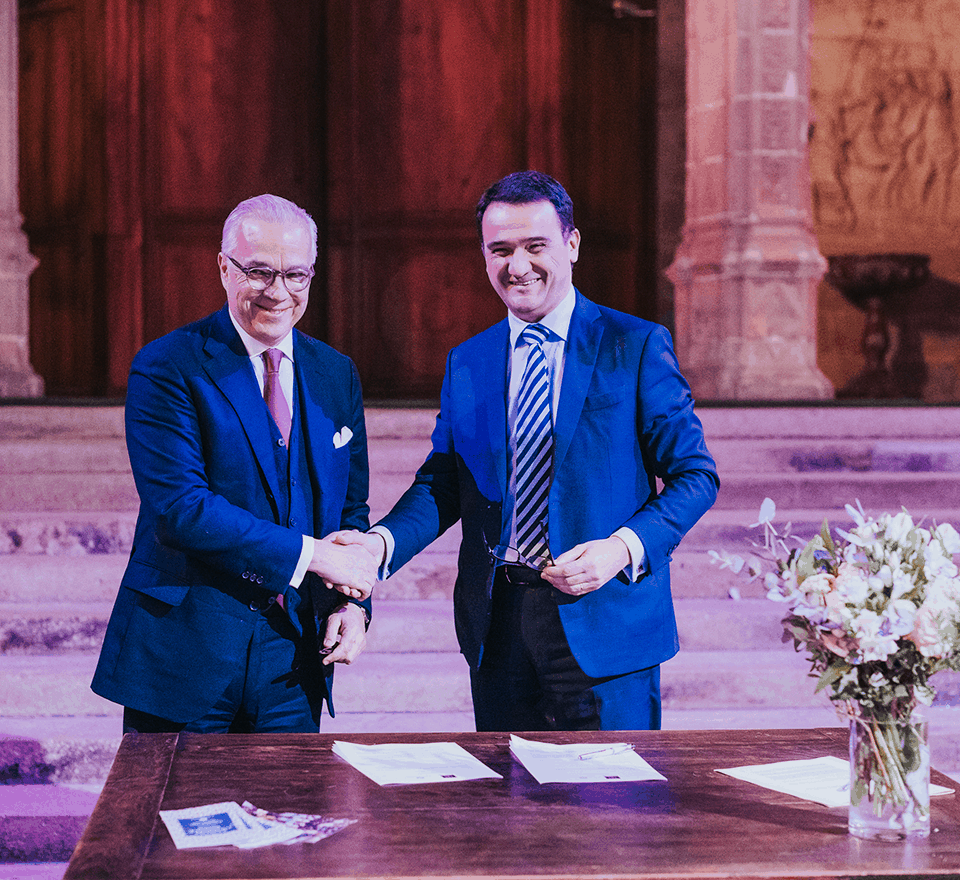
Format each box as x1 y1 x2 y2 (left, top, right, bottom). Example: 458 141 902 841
470 567 660 731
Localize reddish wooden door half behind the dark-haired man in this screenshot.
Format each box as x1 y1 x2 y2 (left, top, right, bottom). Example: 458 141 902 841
327 0 656 399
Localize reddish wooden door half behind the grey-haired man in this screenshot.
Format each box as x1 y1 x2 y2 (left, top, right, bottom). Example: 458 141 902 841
20 0 325 395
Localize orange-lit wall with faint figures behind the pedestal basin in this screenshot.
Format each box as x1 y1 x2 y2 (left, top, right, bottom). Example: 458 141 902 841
810 0 960 402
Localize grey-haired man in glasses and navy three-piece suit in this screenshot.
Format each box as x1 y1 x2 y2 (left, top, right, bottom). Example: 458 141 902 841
92 195 376 732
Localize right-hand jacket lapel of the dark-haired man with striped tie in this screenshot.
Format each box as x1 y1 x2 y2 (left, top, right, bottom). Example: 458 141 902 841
553 291 603 473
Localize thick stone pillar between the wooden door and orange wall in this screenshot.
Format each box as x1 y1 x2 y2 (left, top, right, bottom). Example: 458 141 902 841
668 0 833 400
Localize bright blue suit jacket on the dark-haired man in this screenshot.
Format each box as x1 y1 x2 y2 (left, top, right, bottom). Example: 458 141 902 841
382 292 719 677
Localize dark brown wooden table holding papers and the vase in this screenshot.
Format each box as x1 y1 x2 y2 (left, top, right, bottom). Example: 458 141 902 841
66 728 960 880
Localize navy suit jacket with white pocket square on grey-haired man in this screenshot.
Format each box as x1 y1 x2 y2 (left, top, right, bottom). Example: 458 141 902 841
92 306 369 721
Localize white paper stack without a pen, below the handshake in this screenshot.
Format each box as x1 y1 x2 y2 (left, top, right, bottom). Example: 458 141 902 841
333 741 503 785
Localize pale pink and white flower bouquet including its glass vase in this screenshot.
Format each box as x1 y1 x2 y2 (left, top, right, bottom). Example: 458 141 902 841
710 498 960 839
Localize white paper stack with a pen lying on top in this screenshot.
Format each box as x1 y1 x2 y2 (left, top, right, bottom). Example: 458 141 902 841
510 734 667 784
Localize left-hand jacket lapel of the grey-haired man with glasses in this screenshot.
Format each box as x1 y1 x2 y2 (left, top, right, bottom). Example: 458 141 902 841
204 306 280 506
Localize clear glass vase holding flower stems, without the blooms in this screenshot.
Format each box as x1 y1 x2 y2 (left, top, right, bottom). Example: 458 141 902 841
848 709 930 840
